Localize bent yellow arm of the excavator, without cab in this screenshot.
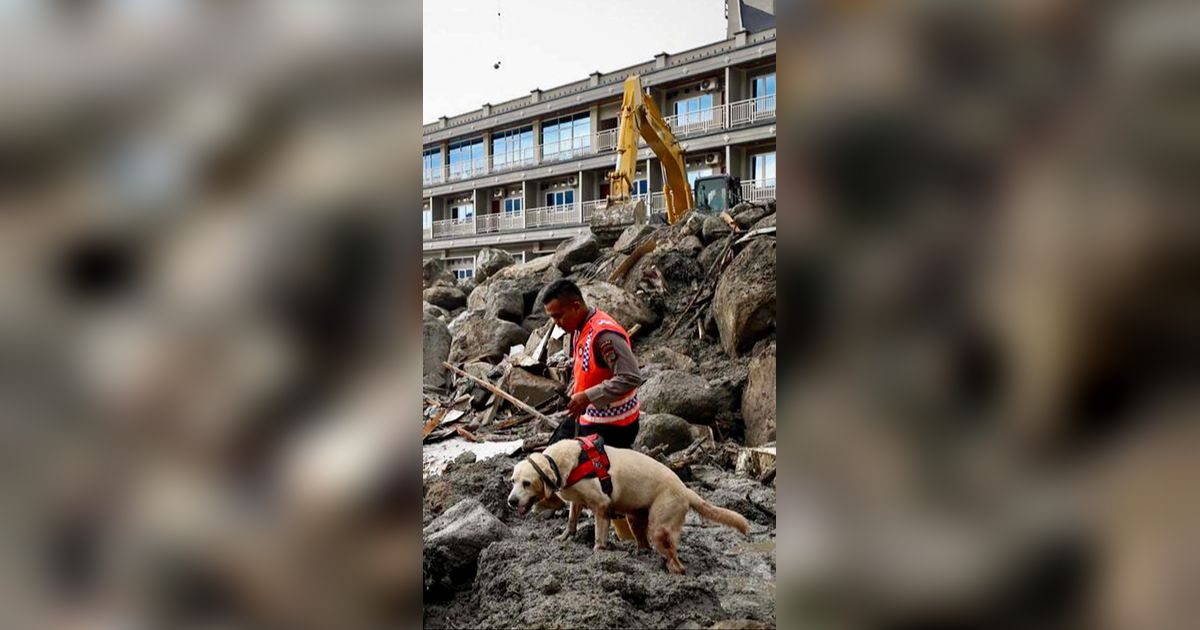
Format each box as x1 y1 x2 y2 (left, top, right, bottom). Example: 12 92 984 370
608 74 695 223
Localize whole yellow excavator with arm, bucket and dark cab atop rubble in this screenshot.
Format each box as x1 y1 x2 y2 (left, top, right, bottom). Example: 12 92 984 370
590 74 742 240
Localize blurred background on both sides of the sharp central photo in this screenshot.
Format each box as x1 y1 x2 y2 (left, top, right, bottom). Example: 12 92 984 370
0 0 1200 629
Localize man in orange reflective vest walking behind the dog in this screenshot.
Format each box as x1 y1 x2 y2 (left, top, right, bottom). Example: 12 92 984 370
542 278 644 449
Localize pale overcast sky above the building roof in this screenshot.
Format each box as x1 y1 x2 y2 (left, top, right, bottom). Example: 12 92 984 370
421 0 725 122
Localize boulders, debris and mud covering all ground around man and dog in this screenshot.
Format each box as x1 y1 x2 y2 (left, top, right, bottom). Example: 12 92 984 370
422 202 776 628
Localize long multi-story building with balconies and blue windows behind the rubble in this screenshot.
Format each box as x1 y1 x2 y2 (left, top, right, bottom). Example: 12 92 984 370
421 0 776 277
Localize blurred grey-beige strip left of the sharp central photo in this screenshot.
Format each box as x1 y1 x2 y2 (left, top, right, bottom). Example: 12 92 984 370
0 0 421 629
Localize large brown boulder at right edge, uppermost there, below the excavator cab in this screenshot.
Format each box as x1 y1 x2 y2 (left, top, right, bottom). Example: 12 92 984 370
713 236 775 356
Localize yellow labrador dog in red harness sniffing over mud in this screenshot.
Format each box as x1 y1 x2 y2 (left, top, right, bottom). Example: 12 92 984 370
509 439 750 574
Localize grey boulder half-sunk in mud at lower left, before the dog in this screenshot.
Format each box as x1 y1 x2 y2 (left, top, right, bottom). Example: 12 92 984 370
421 498 509 598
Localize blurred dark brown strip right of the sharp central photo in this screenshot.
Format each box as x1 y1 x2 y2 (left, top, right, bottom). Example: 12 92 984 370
779 0 1200 629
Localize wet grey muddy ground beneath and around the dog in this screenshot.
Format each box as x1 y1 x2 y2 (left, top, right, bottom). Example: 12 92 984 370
424 456 775 629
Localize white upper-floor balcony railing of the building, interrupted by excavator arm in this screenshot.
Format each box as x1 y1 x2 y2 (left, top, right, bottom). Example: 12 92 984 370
422 94 775 186
